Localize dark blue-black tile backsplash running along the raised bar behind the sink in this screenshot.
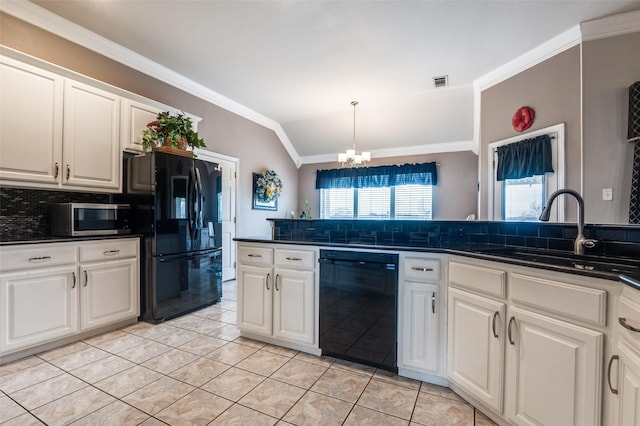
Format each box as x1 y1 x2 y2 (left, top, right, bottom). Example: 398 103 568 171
270 219 640 258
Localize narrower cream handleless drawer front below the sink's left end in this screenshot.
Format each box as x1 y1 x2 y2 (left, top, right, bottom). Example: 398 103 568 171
449 262 506 298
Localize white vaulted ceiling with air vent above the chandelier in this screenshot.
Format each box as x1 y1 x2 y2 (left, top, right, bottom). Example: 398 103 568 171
17 0 640 162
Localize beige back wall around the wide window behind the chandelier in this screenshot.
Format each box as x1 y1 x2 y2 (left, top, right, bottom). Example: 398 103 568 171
296 151 478 220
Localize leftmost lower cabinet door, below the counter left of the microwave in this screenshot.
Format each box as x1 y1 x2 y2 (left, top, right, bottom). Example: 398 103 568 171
0 265 78 353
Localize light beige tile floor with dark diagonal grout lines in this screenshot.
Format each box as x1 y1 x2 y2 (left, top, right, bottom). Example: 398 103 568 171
0 281 493 426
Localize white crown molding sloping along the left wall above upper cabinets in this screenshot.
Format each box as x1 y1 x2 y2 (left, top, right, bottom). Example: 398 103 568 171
0 0 301 167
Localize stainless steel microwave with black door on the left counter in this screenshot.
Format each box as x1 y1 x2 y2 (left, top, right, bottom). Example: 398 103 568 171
51 203 131 237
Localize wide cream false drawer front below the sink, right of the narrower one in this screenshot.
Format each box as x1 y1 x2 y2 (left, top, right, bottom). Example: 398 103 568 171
509 273 607 327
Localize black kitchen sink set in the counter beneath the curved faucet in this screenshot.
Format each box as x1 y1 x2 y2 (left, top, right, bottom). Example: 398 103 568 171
477 247 640 275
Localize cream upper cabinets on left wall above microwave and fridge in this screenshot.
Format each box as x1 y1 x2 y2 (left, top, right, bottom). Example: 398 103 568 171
0 50 201 193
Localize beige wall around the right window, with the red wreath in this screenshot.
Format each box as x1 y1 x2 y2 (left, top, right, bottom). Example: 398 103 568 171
480 46 582 221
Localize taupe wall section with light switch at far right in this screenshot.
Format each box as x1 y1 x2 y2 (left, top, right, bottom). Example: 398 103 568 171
582 32 640 223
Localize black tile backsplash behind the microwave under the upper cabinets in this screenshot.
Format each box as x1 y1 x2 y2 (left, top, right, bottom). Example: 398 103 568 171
0 187 109 242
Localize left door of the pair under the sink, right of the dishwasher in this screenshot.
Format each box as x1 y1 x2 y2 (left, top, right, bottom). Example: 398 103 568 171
447 288 506 413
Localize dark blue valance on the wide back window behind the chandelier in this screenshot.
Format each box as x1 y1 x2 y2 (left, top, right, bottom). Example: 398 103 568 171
316 163 438 189
